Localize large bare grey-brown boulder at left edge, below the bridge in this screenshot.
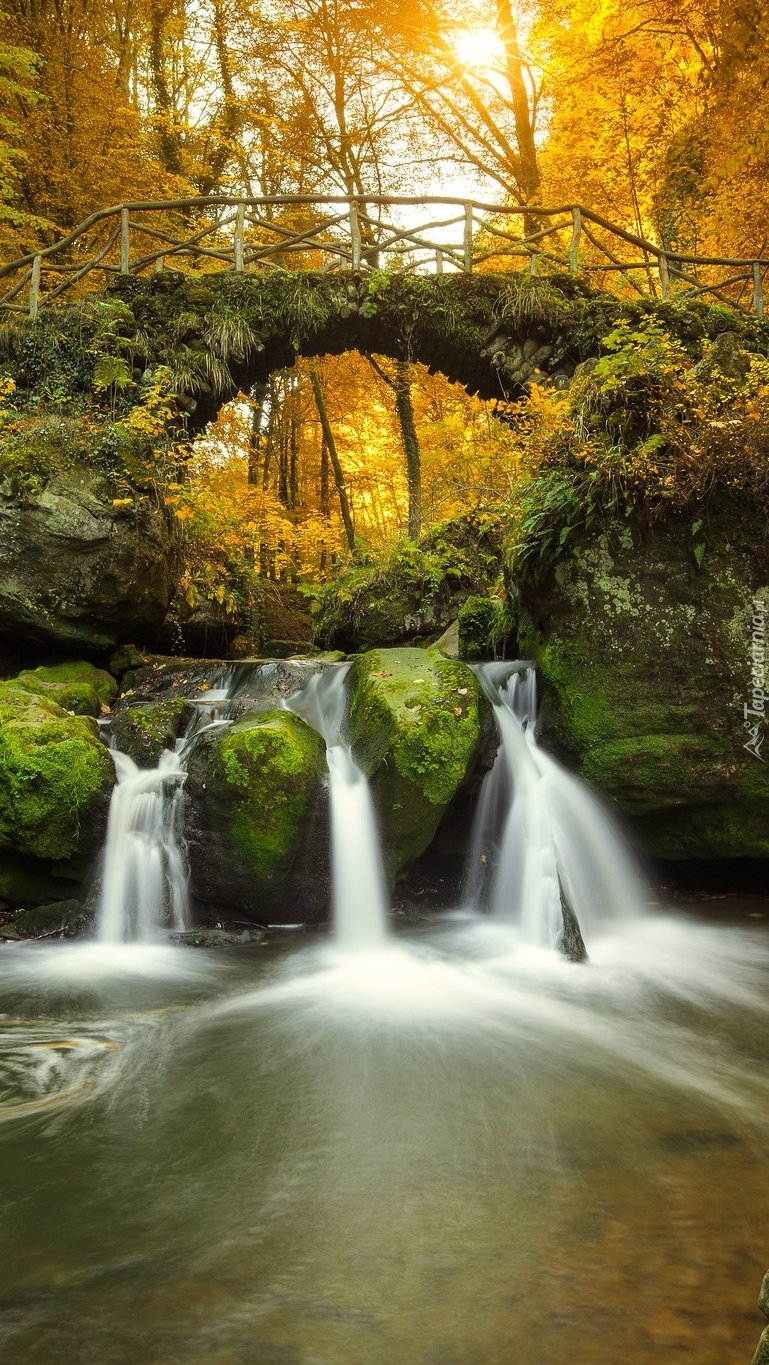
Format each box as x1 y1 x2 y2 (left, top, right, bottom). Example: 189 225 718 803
0 470 178 651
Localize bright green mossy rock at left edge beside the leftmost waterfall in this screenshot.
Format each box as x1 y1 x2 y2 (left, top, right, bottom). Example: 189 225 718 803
0 683 115 859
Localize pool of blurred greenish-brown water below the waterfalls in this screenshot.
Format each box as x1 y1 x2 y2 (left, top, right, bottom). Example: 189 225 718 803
0 915 769 1365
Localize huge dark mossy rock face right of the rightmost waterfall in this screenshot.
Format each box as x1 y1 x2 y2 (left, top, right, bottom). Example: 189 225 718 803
512 501 769 859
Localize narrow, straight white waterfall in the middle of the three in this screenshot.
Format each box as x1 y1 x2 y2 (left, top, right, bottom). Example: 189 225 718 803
285 665 387 953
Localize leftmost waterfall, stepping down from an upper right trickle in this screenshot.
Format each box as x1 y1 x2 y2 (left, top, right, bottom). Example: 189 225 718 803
98 670 232 943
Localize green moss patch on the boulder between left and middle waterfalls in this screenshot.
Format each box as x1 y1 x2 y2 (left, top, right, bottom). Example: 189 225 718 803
209 711 325 876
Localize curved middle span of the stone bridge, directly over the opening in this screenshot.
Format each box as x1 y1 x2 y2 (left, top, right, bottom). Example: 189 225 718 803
96 259 590 430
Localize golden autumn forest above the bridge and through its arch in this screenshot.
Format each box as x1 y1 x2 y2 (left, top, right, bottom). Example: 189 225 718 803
0 0 769 657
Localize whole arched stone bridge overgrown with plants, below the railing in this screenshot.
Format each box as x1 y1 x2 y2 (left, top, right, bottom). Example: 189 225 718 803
7 270 766 433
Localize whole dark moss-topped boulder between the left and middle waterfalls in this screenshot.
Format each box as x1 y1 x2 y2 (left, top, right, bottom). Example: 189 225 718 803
187 710 329 923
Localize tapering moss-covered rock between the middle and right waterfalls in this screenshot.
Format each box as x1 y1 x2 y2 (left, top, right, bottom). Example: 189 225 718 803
347 648 492 876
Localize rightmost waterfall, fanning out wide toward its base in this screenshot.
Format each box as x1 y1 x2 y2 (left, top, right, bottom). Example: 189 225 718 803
467 662 643 957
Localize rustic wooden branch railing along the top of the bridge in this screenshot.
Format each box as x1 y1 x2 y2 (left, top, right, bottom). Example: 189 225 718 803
0 195 769 318
